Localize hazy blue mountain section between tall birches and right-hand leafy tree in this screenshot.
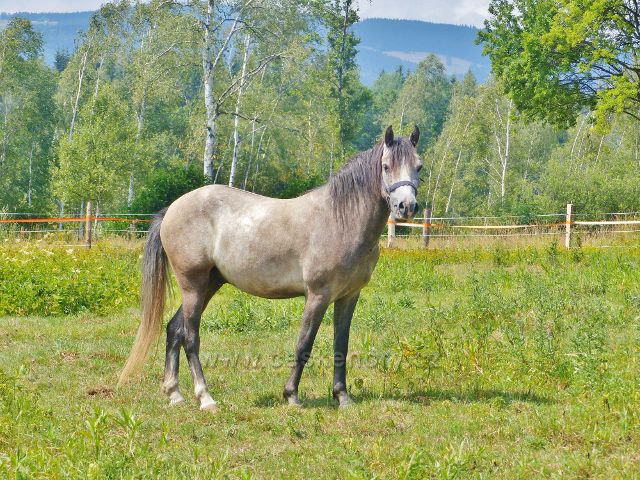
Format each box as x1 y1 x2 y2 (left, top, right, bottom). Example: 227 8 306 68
354 18 491 85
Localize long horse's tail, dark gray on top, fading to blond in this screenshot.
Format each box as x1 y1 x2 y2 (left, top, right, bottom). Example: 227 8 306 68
118 208 169 385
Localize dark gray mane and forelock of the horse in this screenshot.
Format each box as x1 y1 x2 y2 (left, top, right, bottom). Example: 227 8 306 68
327 138 413 217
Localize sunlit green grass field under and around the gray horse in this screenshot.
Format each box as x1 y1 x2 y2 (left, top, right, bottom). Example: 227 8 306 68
0 242 640 479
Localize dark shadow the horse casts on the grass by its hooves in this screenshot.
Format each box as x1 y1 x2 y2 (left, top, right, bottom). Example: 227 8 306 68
253 388 554 408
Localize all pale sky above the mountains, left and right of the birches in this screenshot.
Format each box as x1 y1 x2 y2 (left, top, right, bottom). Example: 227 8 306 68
0 0 489 27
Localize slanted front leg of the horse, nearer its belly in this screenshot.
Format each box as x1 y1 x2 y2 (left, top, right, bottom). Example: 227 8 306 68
284 292 329 405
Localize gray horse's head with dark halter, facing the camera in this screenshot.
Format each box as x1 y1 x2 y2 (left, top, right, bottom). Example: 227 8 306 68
381 126 422 220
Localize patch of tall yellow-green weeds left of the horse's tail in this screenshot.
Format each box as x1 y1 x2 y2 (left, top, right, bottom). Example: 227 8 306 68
0 240 140 316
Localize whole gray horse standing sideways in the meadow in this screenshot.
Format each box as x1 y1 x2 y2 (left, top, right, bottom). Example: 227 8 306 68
120 127 422 411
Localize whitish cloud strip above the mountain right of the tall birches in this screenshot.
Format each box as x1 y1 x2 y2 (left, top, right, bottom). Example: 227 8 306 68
359 0 489 27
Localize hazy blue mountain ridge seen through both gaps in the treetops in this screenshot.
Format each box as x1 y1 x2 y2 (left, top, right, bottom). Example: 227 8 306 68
0 12 491 85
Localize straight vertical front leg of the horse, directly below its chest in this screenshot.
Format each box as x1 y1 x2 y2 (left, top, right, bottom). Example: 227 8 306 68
333 291 360 407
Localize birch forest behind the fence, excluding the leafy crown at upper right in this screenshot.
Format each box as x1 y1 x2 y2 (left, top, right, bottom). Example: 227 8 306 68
0 0 640 216
